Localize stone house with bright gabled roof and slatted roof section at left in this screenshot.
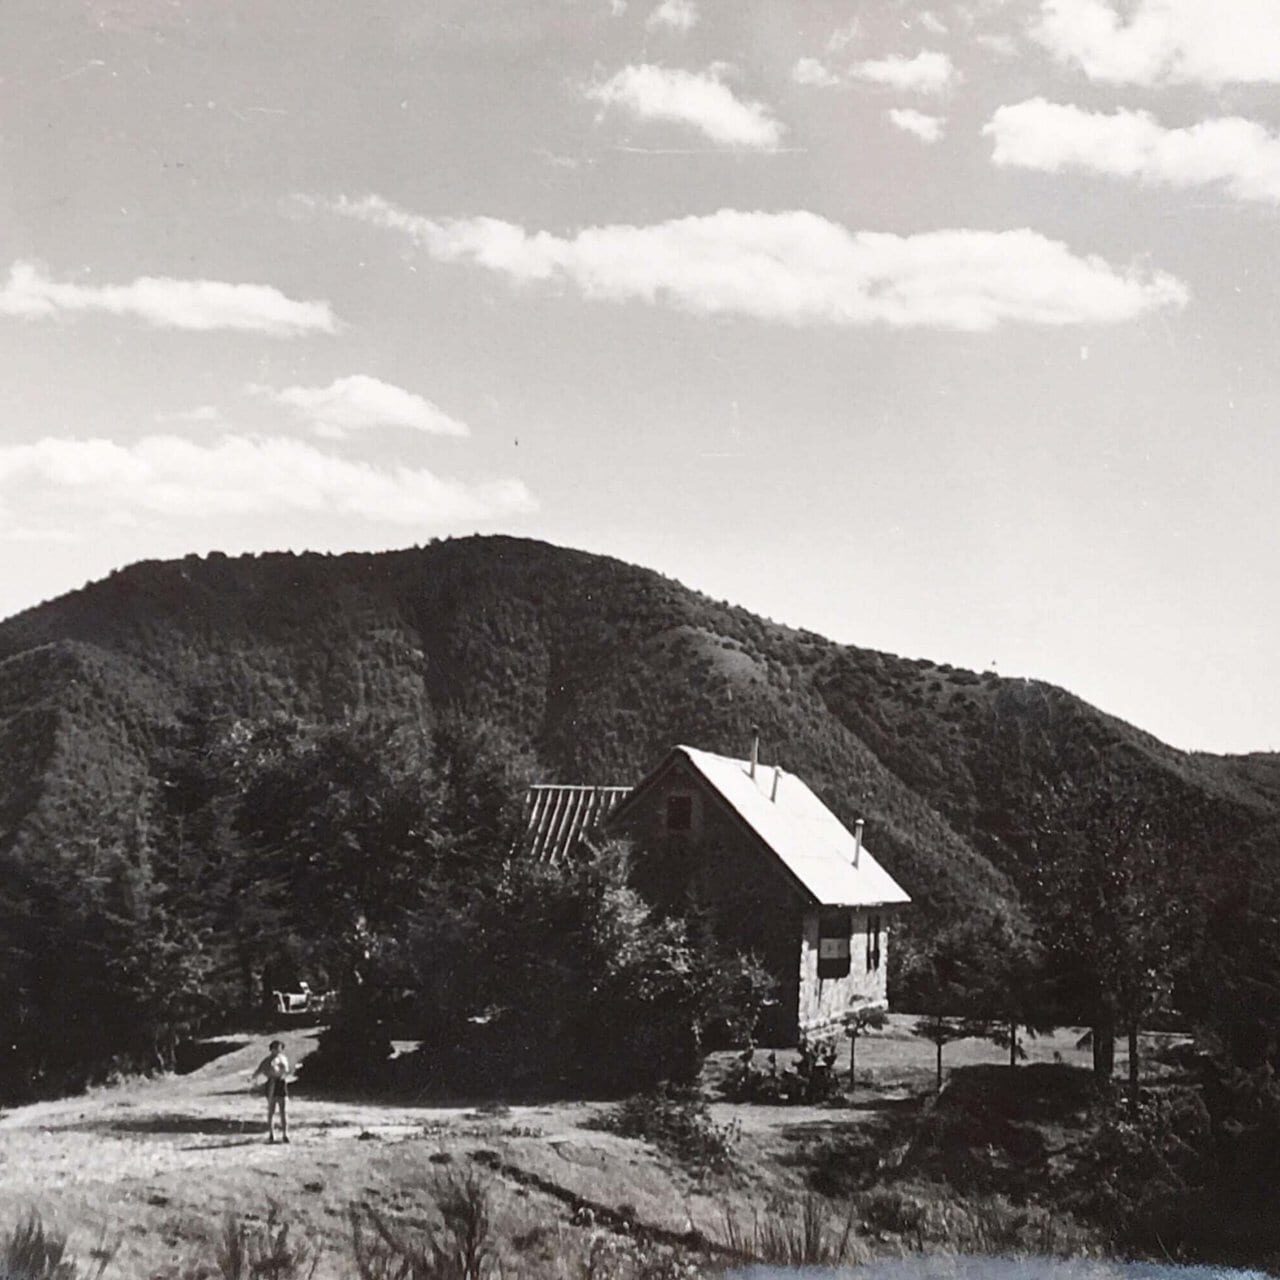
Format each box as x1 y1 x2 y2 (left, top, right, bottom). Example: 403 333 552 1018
519 737 910 1044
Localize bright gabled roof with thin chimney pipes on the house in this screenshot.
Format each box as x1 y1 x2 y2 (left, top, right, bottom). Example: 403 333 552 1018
611 746 910 906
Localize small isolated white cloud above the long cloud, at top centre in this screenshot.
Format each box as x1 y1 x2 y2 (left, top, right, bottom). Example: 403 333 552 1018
586 64 785 151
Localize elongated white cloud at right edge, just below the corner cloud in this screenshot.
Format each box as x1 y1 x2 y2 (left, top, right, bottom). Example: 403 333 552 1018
983 97 1280 201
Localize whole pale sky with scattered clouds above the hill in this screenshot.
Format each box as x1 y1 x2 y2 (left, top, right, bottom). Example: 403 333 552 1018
0 0 1280 751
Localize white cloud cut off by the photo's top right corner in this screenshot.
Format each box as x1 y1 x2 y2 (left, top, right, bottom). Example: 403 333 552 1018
1032 0 1280 86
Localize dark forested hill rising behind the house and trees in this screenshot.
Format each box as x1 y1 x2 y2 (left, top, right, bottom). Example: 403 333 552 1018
0 538 1280 915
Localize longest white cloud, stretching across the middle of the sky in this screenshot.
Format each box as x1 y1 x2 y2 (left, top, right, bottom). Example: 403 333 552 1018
333 196 1187 330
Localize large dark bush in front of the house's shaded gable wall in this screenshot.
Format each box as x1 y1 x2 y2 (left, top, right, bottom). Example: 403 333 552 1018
389 847 768 1093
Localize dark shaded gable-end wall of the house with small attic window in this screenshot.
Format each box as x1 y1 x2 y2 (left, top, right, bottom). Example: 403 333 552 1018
609 759 804 1044
